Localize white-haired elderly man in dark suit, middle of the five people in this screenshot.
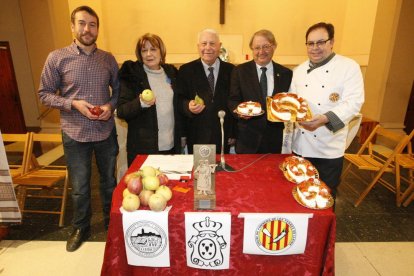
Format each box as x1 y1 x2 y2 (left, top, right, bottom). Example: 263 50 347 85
177 29 235 153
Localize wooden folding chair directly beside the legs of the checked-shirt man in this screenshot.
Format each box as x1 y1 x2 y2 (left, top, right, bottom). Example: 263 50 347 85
14 133 68 226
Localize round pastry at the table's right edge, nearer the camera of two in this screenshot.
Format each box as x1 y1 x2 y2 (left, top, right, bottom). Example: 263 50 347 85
296 178 332 209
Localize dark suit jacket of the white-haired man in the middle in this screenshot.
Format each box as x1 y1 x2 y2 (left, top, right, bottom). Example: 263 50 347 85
177 59 236 153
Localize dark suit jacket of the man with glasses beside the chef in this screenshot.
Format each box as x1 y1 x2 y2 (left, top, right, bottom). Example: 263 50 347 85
228 61 292 153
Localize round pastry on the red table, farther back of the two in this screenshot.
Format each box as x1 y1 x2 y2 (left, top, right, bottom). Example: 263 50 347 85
282 156 318 183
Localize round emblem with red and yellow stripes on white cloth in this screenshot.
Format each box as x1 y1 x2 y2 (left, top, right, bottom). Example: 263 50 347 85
255 218 296 255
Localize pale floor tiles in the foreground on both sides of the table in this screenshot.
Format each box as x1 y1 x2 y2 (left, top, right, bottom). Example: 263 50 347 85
0 240 414 276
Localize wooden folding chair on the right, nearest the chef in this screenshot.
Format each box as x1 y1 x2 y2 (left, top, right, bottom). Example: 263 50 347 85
342 125 413 207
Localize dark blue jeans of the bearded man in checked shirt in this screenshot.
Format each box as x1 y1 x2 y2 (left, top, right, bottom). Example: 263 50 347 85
62 128 118 229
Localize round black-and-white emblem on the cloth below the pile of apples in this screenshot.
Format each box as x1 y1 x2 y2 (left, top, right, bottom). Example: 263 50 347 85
125 221 167 258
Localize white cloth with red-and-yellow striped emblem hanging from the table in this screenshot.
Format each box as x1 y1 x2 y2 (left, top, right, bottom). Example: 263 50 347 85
239 213 313 255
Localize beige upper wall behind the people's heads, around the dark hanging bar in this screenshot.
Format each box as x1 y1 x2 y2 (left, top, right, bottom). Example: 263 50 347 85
68 0 377 65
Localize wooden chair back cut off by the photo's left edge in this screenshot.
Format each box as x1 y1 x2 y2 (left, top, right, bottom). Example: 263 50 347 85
2 132 30 178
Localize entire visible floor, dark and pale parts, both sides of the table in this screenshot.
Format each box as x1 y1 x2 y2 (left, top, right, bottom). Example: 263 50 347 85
0 141 414 276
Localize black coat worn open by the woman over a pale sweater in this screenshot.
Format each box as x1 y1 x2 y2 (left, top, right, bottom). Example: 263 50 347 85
117 61 183 165
